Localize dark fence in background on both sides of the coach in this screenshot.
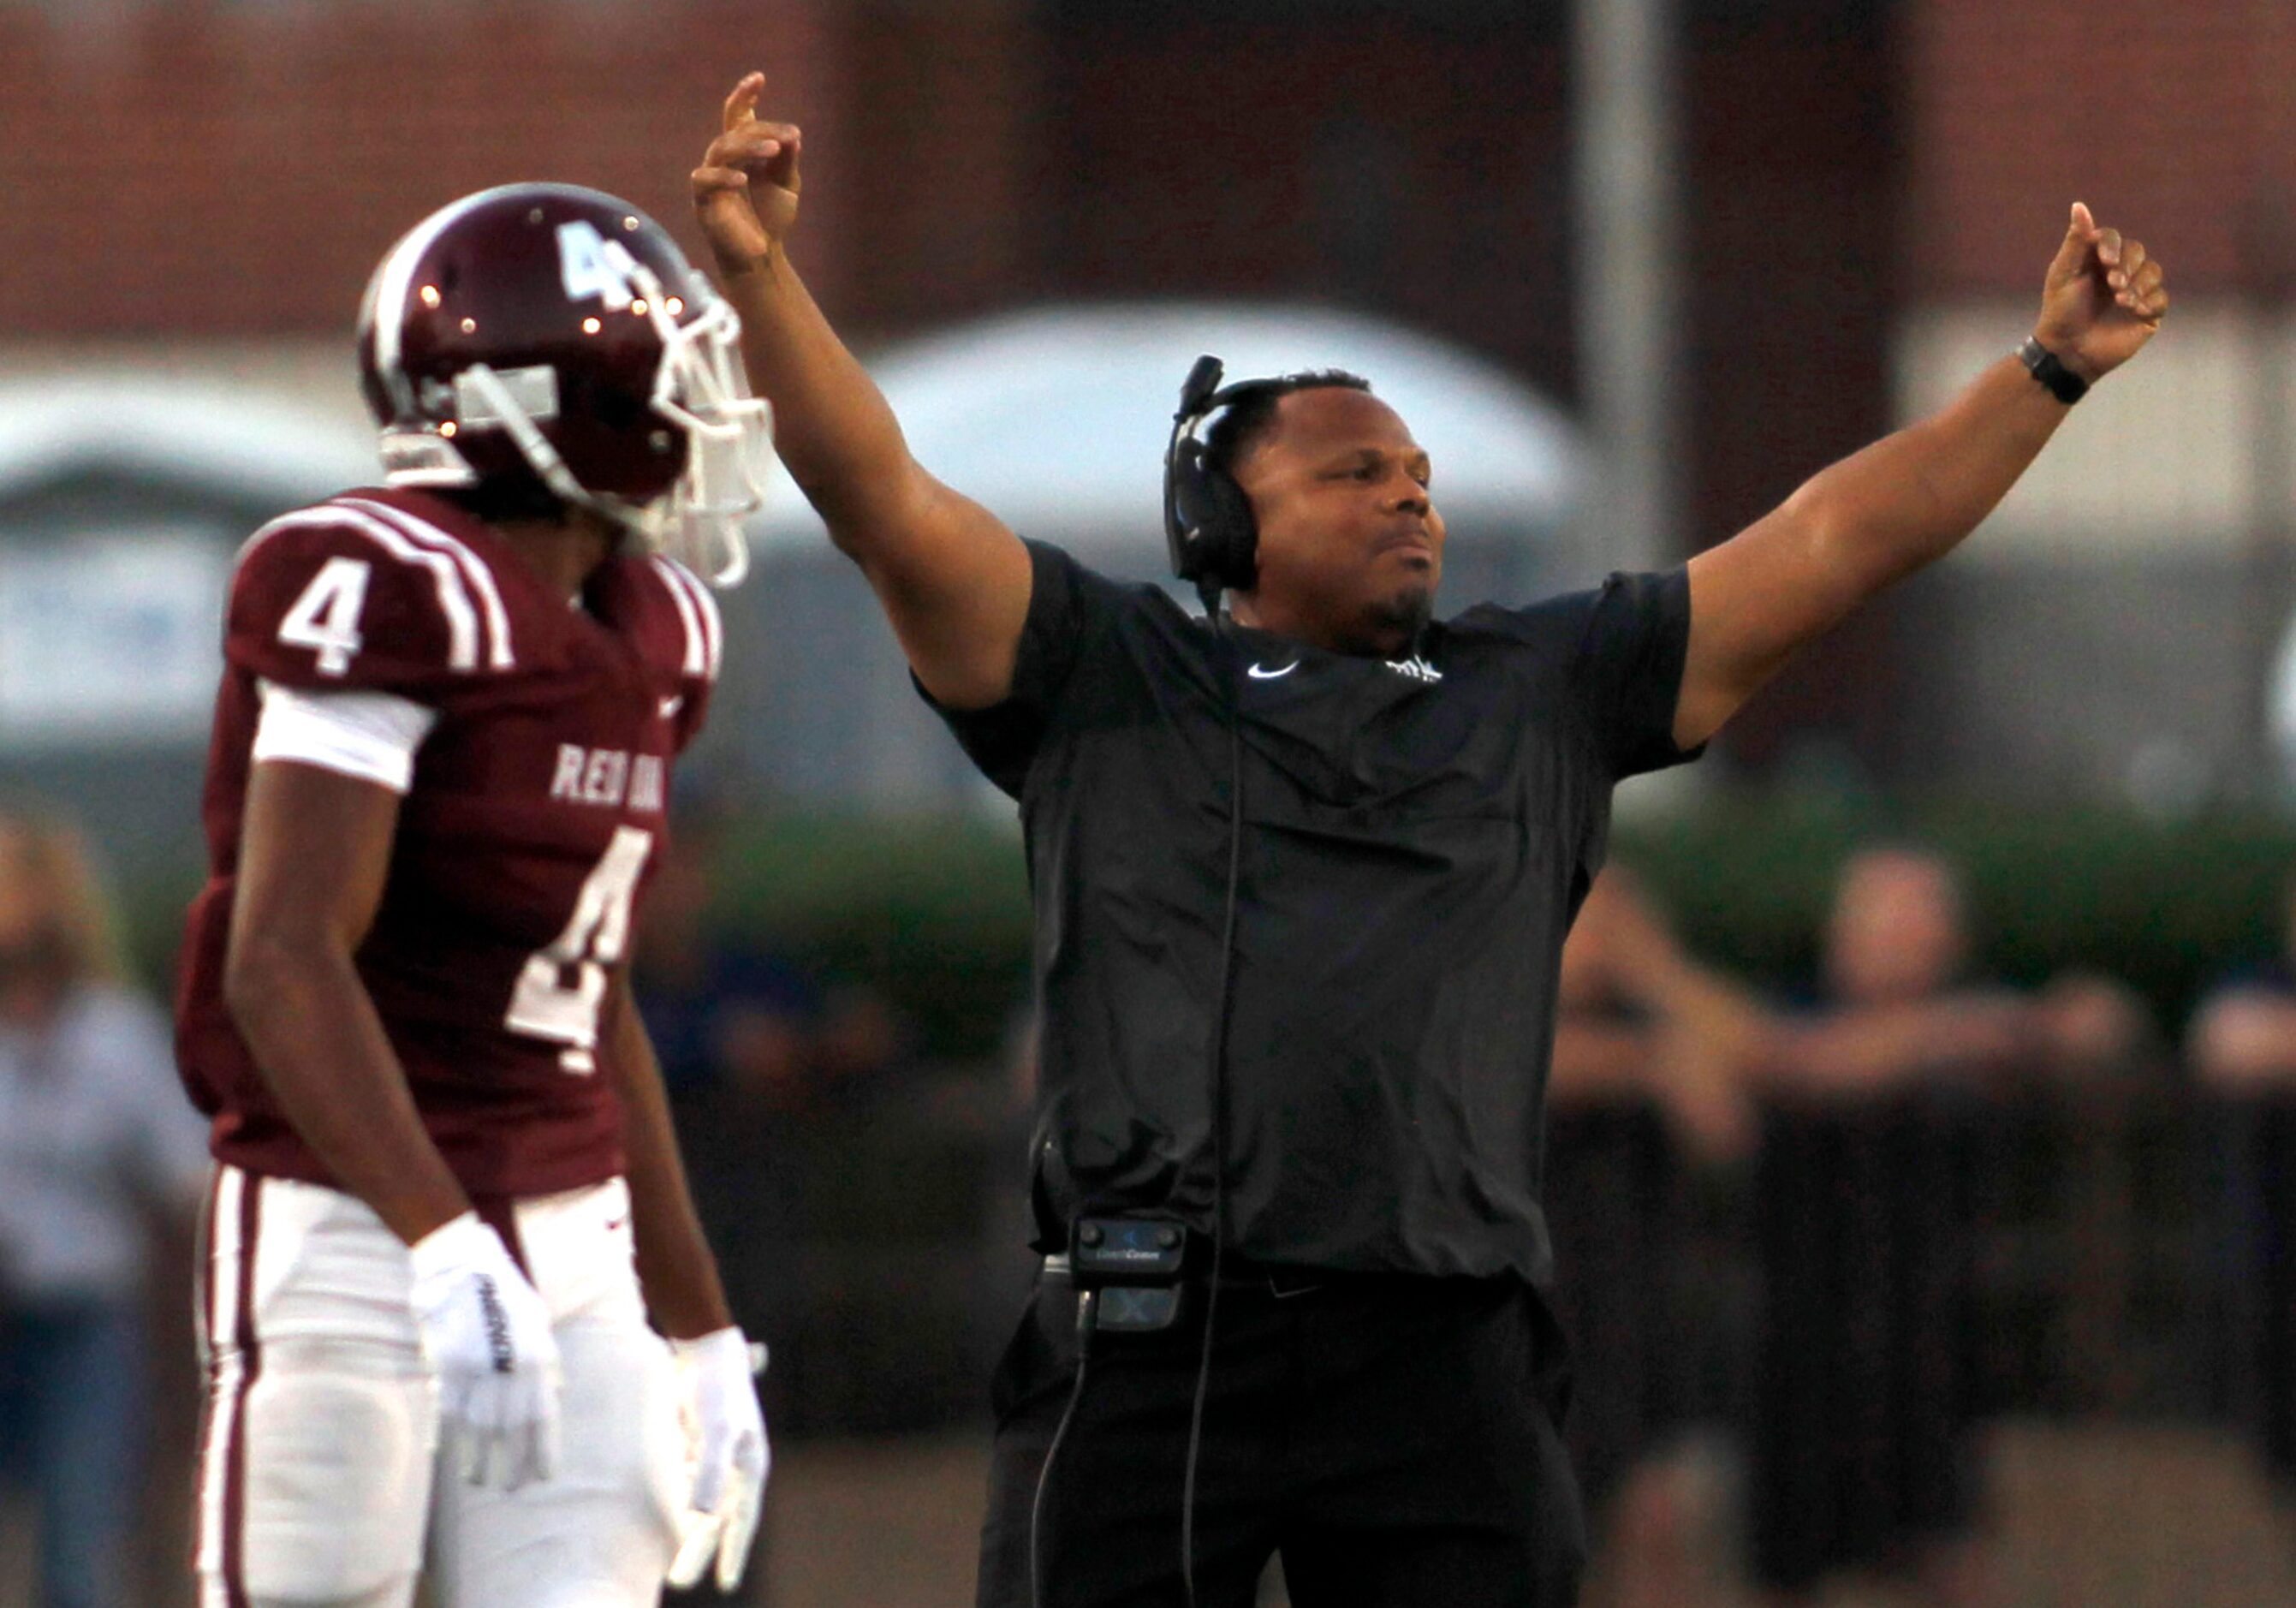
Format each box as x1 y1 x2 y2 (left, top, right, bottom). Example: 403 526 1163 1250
684 1075 2296 1585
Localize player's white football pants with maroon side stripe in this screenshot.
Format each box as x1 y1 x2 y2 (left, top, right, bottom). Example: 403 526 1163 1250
195 1167 687 1608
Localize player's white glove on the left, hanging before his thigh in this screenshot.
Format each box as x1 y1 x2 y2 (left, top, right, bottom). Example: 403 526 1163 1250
407 1211 560 1491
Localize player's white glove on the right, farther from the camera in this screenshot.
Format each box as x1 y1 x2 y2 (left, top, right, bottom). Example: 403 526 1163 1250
670 1328 774 1592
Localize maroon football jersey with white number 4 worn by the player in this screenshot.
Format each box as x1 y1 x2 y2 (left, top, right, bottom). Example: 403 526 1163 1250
177 489 721 1194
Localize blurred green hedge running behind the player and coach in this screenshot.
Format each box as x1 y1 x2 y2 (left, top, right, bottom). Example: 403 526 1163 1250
127 795 2296 1057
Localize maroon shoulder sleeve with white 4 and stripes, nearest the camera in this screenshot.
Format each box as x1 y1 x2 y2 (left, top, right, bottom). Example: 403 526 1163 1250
223 505 509 706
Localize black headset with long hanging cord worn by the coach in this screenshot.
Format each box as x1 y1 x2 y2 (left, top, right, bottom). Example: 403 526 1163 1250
1029 356 1288 1608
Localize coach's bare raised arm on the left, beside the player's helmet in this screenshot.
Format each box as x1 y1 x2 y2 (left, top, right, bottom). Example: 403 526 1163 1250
693 74 1029 707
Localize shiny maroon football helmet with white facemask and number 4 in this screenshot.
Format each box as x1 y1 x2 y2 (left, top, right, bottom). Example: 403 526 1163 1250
358 184 771 586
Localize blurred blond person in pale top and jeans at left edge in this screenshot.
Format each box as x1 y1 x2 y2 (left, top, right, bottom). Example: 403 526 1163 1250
0 807 209 1608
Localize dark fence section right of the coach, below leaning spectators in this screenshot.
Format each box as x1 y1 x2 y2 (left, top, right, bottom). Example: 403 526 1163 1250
1548 1077 2296 1590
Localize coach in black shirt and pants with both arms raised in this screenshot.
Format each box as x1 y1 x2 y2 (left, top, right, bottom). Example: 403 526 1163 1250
693 74 2168 1608
